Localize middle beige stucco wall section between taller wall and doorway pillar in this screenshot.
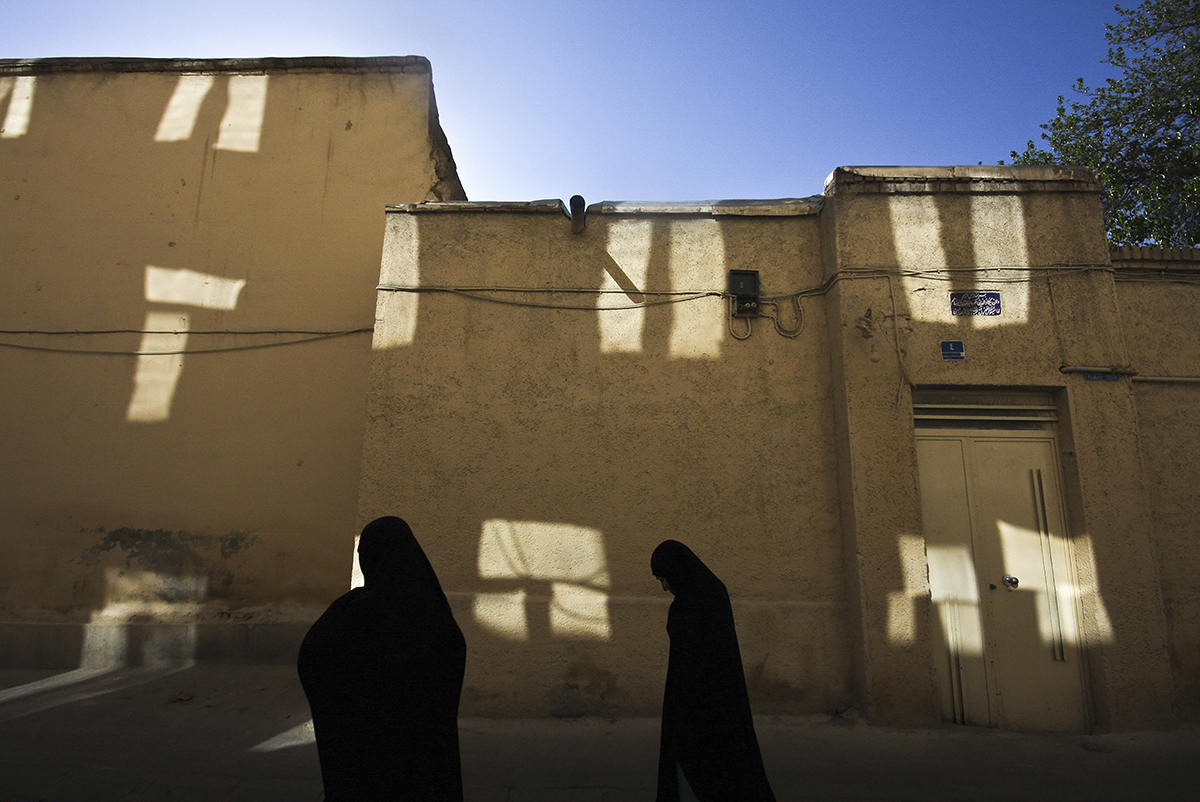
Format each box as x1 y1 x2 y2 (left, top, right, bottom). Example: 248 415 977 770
359 203 850 716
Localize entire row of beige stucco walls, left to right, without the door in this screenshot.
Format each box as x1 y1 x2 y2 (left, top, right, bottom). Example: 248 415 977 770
0 95 1180 729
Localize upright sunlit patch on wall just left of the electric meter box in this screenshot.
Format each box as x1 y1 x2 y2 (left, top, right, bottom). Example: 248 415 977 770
668 220 726 359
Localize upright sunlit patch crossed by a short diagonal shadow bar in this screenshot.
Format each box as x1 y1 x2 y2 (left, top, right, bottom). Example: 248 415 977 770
596 220 653 353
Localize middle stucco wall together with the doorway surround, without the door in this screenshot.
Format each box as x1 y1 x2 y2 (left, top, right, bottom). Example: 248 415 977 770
359 168 1172 729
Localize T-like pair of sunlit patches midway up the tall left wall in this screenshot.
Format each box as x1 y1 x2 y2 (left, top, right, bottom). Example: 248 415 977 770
125 265 246 423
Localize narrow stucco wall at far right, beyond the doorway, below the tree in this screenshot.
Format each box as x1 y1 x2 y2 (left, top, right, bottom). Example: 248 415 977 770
1112 249 1200 718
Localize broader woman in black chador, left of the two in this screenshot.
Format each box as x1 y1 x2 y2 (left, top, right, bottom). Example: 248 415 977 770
298 517 467 802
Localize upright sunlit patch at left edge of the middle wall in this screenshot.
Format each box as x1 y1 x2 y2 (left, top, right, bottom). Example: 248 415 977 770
371 215 421 351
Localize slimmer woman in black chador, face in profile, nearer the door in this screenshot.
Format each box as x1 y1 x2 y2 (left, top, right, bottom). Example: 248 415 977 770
650 540 775 802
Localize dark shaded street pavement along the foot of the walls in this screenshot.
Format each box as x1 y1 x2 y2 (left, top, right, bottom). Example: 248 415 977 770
0 666 1200 802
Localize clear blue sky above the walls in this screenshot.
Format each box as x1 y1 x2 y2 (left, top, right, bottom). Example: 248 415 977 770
0 0 1136 202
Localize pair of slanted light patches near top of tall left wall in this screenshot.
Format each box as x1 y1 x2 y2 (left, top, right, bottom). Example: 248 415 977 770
155 73 268 152
